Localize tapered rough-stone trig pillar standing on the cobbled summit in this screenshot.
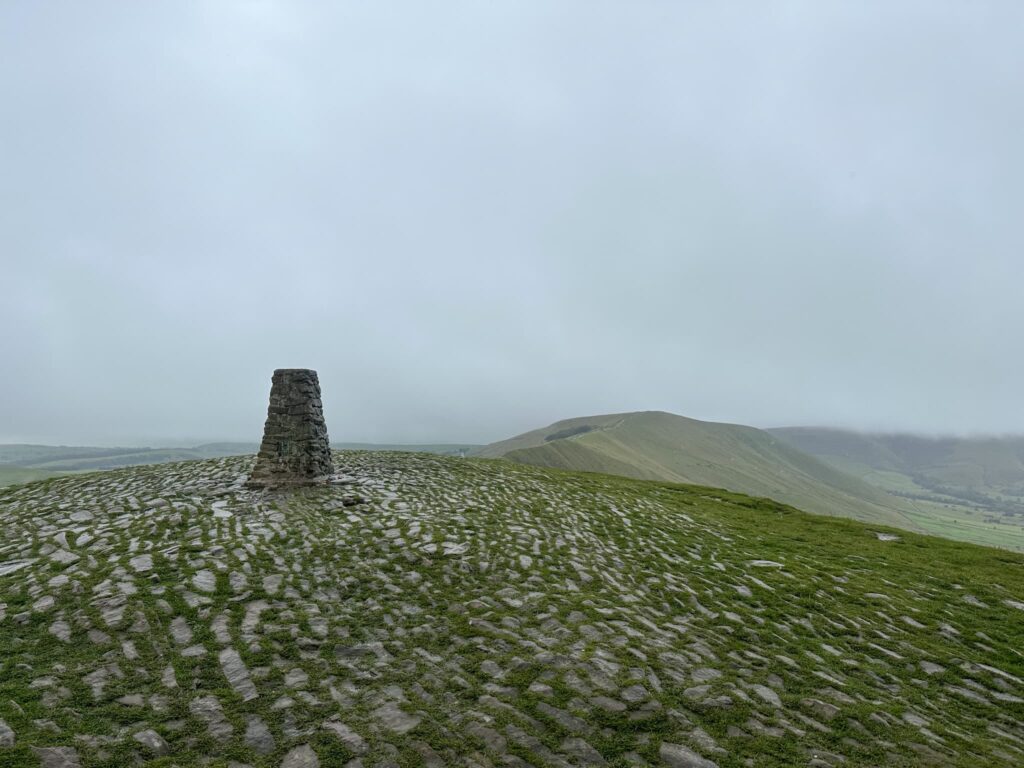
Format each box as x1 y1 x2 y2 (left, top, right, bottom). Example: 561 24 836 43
249 368 334 487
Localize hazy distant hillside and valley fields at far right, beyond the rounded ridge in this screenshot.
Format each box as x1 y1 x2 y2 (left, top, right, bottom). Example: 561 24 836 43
768 427 1024 544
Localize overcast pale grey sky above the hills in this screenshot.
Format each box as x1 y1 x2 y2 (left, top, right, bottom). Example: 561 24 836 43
0 0 1024 443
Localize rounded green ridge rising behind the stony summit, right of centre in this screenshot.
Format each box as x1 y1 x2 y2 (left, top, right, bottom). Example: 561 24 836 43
478 412 918 529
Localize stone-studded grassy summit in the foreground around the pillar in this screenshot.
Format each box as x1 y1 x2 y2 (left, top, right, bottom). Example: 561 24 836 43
0 454 1024 768
